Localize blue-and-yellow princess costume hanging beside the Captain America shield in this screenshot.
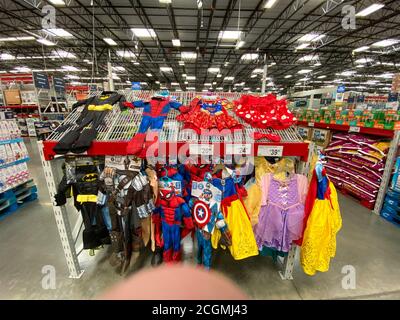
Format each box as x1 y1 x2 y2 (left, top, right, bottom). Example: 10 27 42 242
211 170 258 260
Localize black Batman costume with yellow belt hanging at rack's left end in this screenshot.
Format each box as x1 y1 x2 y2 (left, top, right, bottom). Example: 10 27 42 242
54 157 110 249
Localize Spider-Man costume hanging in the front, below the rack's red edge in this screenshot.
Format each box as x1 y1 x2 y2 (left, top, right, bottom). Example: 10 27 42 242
153 188 194 263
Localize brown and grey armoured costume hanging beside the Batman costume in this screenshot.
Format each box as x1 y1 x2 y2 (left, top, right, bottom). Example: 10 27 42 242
101 156 155 272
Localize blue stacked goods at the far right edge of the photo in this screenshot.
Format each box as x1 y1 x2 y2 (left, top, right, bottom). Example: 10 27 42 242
381 157 400 226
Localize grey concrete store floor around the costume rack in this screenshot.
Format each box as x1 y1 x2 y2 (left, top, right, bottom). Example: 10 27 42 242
0 139 400 299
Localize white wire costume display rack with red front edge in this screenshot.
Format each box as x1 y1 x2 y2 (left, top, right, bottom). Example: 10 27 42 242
38 90 314 280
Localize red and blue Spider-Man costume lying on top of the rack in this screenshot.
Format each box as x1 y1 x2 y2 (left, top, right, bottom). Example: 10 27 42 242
126 96 182 158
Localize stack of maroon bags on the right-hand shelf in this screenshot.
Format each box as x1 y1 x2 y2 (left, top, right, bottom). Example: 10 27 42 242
325 133 390 209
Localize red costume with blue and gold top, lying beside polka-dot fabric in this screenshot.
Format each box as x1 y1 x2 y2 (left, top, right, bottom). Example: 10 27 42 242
176 97 242 134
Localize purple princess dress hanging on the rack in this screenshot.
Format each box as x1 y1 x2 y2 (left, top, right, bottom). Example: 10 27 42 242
254 173 308 252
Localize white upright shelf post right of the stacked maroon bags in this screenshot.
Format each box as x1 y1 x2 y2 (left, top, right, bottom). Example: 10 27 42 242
373 131 400 215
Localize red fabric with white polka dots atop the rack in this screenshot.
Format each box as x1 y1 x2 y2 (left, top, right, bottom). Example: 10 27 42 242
235 94 297 130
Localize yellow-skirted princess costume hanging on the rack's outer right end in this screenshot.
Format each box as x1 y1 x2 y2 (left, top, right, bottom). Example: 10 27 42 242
300 163 342 275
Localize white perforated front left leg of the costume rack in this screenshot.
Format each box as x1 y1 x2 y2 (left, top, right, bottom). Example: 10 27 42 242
38 141 83 279
